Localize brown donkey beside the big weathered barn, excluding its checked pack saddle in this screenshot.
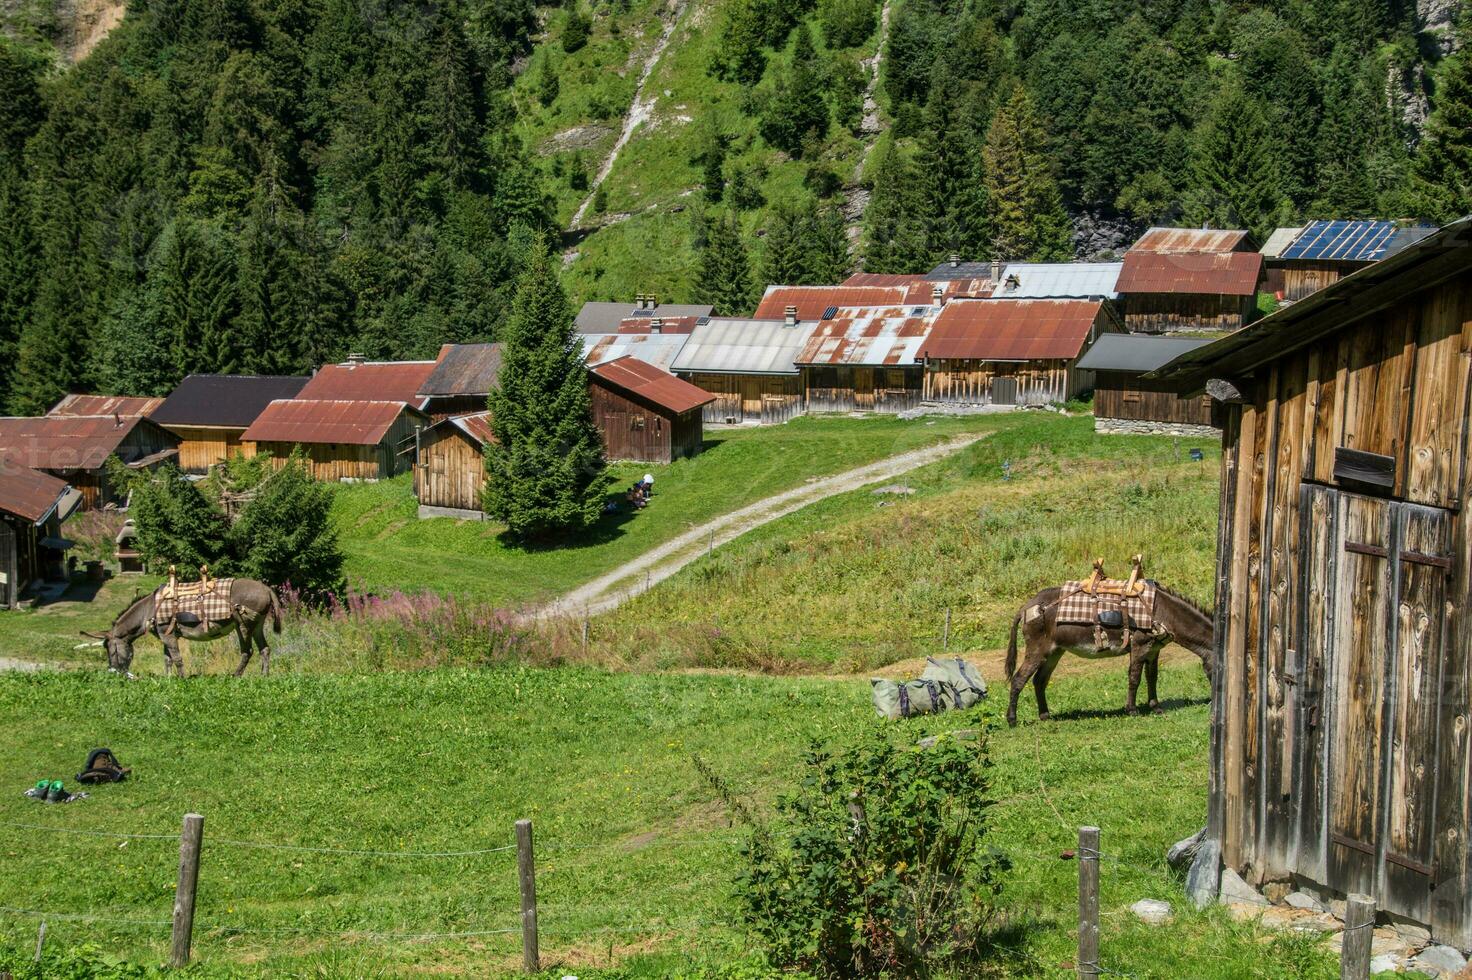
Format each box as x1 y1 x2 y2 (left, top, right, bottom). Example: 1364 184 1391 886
1007 584 1214 725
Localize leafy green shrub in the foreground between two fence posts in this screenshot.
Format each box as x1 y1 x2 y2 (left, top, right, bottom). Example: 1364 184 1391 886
698 733 1007 977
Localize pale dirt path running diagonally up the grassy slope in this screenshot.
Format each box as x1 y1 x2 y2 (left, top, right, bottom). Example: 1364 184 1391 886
531 433 989 617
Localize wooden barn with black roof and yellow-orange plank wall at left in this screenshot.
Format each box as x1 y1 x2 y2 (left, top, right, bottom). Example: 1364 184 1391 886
150 374 308 474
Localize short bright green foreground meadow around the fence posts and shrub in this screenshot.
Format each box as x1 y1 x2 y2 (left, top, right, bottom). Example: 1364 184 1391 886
0 667 1329 977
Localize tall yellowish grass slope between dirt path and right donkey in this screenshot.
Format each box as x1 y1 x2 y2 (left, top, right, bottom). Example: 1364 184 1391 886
593 415 1219 671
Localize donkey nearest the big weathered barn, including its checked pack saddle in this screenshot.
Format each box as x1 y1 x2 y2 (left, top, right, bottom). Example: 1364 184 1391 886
1007 555 1214 725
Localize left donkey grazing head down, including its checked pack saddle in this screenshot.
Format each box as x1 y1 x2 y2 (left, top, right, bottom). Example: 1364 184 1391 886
82 565 281 677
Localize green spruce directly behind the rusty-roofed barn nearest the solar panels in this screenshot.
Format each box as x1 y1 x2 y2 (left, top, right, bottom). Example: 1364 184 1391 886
1189 84 1284 241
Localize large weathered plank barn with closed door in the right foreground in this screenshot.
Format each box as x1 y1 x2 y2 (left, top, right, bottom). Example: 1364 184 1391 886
1156 219 1472 949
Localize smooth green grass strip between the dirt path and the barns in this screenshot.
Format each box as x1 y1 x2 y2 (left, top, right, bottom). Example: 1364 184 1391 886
334 415 1016 605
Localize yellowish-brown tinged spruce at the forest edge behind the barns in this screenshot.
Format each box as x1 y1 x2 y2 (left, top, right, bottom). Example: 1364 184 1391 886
982 85 1073 262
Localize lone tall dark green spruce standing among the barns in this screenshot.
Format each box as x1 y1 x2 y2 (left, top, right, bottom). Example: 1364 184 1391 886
483 241 608 542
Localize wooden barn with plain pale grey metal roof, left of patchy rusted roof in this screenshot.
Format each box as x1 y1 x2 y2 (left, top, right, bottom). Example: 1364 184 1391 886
671 315 817 424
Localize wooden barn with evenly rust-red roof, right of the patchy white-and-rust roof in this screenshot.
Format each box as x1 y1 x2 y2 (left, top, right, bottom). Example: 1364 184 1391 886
920 299 1119 405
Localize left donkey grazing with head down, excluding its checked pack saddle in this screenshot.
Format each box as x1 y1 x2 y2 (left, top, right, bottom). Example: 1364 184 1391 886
82 578 281 677
